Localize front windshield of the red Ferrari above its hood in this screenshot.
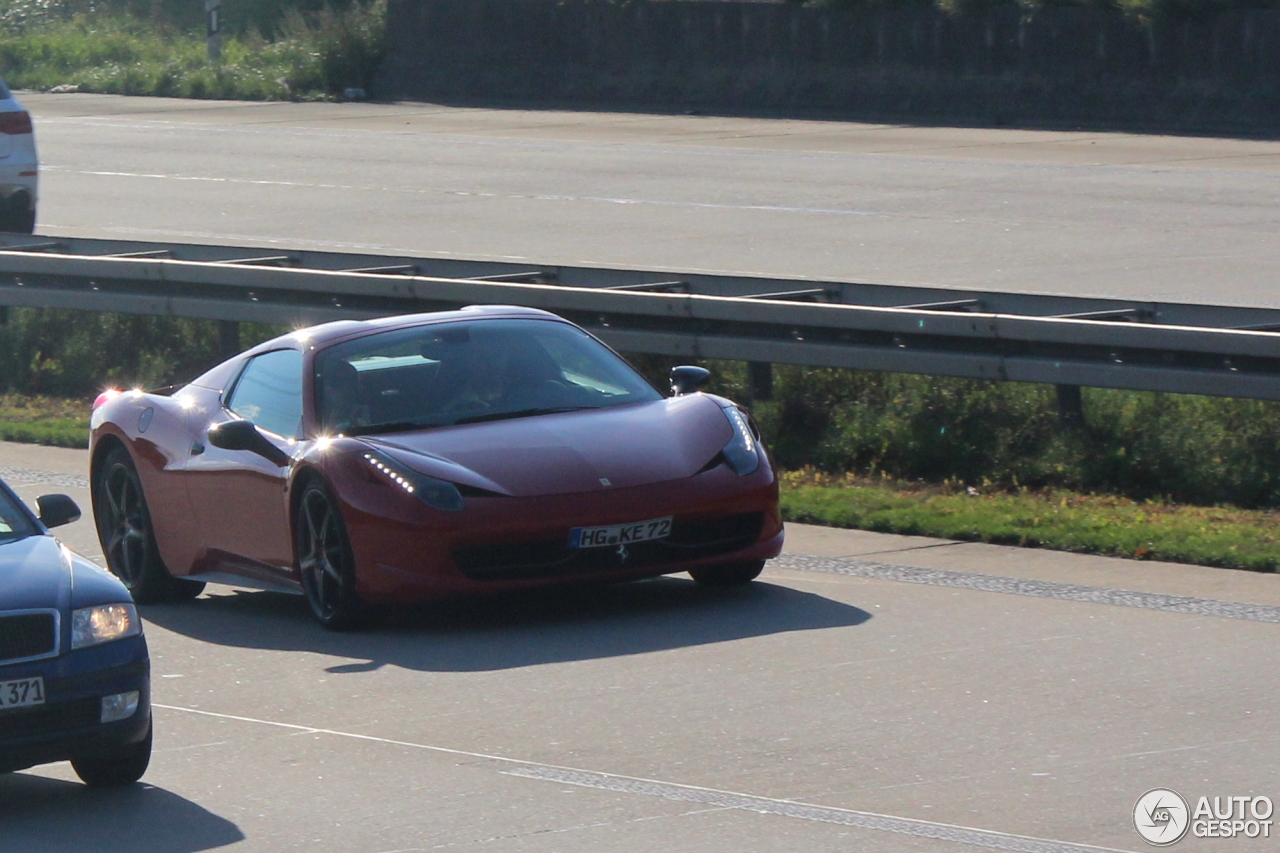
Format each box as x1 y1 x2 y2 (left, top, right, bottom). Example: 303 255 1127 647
315 320 660 434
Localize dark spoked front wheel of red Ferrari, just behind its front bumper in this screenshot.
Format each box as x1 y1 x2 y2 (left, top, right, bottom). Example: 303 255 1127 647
294 482 367 631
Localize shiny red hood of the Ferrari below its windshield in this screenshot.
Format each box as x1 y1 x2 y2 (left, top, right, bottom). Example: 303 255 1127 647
365 394 733 497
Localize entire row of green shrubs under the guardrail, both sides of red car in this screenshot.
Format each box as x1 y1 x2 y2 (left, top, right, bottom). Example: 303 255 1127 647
0 309 1280 507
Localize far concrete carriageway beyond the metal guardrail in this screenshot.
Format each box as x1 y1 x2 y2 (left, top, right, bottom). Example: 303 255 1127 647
22 93 1280 306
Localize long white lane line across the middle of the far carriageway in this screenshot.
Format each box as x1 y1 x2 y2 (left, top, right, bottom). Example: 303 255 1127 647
44 165 890 216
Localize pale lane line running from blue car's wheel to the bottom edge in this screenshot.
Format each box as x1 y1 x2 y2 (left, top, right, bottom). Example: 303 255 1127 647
152 704 1132 853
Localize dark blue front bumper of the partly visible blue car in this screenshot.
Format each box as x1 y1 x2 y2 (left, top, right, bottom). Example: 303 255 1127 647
0 637 151 772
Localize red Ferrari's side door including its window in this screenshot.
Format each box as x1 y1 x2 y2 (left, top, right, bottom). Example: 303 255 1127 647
186 350 302 580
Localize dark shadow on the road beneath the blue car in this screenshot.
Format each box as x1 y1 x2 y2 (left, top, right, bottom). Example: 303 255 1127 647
0 772 244 853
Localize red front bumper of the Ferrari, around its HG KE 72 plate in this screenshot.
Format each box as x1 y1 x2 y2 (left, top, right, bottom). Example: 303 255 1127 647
337 465 782 603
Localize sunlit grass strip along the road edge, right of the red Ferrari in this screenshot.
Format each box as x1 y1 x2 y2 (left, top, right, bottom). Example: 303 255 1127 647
782 471 1280 571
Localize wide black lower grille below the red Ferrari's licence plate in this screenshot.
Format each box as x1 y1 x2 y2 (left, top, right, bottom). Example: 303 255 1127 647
453 512 764 580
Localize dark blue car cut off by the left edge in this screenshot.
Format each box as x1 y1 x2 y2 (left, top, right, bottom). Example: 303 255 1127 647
0 473 151 786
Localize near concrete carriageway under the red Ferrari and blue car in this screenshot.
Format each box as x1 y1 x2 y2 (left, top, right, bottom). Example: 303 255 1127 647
0 444 1280 853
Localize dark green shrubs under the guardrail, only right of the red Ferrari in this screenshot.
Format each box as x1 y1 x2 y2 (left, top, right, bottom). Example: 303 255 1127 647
622 356 1280 507
